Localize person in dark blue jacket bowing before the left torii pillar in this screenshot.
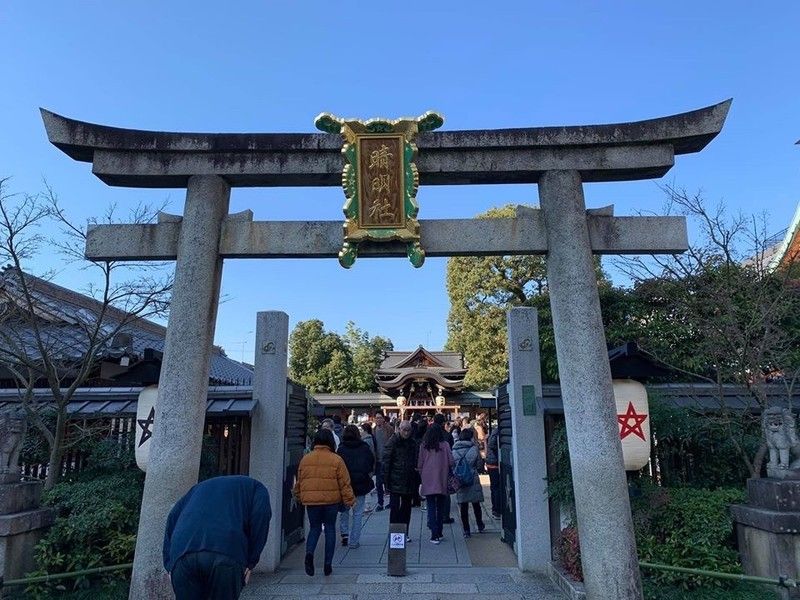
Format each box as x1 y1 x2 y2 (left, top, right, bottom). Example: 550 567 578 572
164 475 272 600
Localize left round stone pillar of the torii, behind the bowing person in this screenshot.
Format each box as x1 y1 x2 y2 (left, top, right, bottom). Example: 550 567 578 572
131 175 230 597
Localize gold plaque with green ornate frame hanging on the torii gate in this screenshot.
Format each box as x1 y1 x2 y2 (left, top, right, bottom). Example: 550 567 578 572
314 111 444 269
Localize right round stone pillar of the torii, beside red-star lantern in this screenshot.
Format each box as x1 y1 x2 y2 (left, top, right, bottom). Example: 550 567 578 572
539 171 642 598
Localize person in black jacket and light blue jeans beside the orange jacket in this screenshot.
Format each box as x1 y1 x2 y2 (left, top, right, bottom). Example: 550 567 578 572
336 425 375 548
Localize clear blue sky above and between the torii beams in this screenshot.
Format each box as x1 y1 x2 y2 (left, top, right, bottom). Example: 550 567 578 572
0 0 800 360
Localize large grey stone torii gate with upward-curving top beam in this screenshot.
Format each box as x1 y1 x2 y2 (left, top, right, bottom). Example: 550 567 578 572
42 100 730 599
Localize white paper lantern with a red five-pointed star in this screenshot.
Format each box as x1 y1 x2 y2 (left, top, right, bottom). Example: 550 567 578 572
613 379 650 471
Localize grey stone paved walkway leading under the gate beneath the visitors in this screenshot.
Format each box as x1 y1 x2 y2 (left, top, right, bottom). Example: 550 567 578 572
241 482 564 600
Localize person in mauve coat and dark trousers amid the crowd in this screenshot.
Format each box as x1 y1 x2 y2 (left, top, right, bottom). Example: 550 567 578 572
417 423 453 544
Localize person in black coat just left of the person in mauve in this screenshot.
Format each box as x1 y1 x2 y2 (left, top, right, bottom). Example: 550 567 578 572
383 421 419 542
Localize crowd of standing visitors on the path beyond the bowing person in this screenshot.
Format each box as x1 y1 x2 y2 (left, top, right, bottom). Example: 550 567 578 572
294 412 500 576
